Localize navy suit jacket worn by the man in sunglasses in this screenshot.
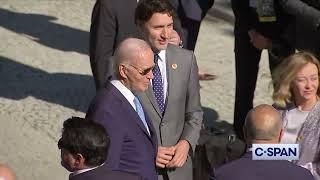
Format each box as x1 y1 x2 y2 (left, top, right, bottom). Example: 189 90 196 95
87 82 158 180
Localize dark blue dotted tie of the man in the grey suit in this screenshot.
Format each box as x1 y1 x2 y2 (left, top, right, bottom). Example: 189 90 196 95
152 54 164 113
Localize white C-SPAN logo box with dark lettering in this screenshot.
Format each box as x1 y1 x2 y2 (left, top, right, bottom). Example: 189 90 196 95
252 144 299 160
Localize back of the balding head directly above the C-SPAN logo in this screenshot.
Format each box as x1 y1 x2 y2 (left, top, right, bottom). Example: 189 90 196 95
244 104 282 143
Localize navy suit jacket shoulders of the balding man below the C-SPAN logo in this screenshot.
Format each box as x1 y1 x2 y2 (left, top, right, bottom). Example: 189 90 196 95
210 152 314 180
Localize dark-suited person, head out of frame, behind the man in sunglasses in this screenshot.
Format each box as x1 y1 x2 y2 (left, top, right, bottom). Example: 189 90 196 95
89 0 139 90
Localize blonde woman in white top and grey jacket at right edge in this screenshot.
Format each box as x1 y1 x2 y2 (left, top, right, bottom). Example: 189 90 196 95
273 52 320 179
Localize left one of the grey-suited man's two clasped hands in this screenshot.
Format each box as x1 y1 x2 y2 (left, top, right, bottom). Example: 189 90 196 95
156 146 174 168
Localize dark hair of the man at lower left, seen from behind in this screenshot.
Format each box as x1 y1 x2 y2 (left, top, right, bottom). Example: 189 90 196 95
58 117 110 167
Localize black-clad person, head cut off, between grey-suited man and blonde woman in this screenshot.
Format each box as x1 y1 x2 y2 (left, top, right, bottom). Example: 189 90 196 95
231 0 294 139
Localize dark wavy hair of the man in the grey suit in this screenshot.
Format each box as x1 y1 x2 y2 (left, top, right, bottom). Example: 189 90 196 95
134 0 176 26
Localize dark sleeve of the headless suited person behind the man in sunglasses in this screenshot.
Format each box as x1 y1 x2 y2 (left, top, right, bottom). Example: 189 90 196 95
90 0 116 89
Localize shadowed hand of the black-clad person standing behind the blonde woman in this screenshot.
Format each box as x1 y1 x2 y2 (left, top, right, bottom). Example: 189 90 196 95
248 30 272 50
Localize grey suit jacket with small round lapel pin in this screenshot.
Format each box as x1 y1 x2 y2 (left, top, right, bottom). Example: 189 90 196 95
140 45 203 180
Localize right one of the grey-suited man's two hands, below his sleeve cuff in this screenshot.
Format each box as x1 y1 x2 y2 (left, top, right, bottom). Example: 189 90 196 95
166 140 190 168
